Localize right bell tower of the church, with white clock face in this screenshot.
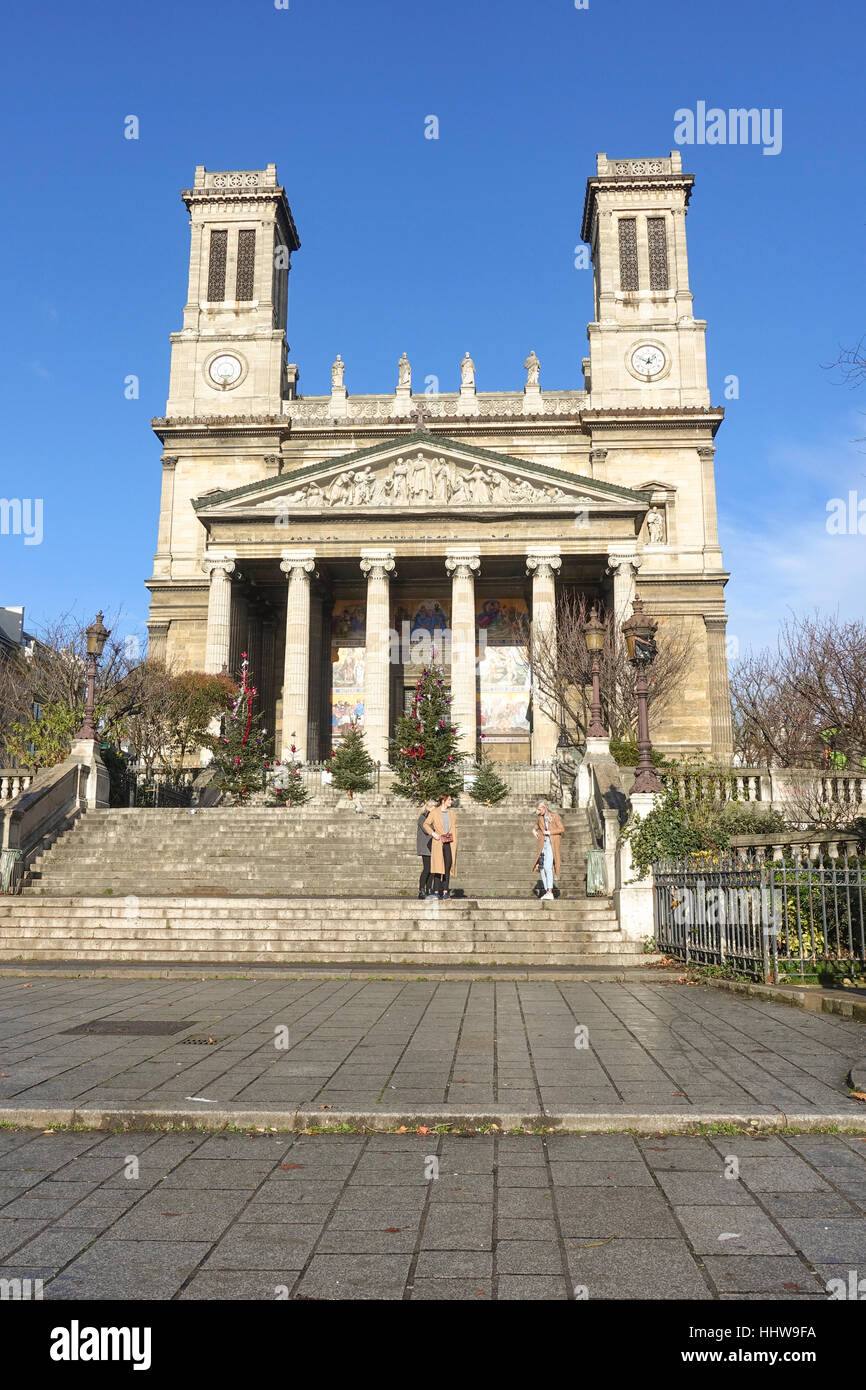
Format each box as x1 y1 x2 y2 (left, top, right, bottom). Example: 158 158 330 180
581 150 709 410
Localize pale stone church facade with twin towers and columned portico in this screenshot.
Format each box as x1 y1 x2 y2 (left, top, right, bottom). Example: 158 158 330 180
147 152 731 763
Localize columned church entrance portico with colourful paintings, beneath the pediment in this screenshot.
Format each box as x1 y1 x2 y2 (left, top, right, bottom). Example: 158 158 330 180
191 530 636 763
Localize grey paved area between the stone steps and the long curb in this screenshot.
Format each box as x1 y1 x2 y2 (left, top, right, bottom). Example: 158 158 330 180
0 977 866 1117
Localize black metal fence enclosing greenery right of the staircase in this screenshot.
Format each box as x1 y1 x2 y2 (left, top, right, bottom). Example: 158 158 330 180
653 855 866 983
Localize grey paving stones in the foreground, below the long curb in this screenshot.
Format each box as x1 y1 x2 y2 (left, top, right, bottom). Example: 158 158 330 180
0 1130 866 1301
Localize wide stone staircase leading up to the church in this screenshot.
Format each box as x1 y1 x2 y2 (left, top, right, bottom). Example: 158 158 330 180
0 803 648 967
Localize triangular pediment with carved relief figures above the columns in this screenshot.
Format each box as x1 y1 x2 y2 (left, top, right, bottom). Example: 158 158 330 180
193 430 646 518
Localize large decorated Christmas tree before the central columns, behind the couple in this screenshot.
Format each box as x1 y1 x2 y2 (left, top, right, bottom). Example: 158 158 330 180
391 666 463 802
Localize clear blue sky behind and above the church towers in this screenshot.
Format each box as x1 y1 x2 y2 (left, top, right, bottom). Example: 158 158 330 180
0 0 866 658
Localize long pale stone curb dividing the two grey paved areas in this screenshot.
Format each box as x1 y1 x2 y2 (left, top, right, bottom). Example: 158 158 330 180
0 1105 866 1134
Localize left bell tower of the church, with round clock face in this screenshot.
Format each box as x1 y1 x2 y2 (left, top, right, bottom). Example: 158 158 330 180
165 164 300 418
